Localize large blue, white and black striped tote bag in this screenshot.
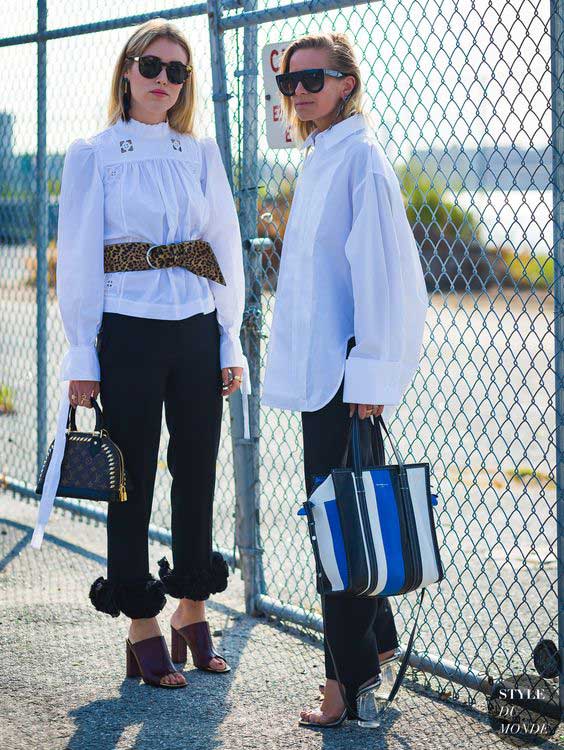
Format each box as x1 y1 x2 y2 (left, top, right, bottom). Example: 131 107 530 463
303 412 444 597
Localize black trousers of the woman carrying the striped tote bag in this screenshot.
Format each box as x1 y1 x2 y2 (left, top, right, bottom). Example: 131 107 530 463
301 340 398 706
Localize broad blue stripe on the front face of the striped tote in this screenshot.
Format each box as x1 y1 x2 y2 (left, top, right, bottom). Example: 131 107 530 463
369 469 405 596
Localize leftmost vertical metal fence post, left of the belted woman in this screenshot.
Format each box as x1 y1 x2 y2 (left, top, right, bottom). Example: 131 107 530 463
35 0 49 482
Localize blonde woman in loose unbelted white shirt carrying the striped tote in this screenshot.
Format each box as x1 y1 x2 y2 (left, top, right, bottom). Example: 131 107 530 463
262 33 428 727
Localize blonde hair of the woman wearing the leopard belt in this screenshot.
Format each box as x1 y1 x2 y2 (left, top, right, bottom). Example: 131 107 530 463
108 18 196 135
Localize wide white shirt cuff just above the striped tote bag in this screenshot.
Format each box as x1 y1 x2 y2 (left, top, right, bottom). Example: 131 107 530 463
343 357 417 405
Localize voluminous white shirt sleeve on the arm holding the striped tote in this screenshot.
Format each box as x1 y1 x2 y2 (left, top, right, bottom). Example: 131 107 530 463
343 167 429 405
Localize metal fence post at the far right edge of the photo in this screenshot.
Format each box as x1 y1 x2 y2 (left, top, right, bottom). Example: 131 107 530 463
550 0 564 717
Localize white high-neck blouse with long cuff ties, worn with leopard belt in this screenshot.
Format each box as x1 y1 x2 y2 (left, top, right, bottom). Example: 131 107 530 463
32 119 250 548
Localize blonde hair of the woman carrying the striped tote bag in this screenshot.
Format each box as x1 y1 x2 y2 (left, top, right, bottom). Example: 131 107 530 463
280 32 363 141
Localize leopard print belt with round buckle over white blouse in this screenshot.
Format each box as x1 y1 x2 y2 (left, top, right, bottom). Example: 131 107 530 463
104 240 226 286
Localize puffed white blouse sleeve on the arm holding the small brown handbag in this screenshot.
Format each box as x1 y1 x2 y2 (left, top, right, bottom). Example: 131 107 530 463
57 139 104 380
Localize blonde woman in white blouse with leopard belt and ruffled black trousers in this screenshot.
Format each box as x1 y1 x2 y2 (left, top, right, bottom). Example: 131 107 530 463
32 19 247 688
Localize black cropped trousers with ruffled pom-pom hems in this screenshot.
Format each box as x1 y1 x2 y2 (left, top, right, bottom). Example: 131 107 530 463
87 311 228 618
